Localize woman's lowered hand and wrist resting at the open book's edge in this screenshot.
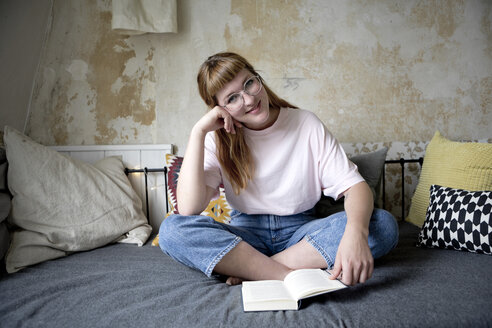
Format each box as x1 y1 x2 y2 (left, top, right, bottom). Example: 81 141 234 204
331 225 374 285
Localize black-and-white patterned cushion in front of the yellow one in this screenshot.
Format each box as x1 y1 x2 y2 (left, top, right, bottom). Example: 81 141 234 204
417 185 492 255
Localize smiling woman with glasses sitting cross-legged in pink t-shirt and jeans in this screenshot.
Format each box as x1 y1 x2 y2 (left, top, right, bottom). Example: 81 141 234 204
159 53 398 285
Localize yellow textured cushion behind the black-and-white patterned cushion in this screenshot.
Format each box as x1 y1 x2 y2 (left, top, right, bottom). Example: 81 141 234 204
407 131 492 226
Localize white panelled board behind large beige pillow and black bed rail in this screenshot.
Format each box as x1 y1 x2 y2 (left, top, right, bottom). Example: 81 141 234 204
50 144 172 233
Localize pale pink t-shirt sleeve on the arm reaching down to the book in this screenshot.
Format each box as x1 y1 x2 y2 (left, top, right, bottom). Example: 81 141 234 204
318 124 364 199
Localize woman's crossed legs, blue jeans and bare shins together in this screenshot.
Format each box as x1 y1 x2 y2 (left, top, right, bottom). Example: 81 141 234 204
159 210 398 284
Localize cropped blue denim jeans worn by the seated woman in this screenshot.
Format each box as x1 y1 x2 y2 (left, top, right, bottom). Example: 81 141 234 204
159 209 398 277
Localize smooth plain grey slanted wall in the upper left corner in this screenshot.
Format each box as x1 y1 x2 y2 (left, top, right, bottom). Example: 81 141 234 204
0 0 52 135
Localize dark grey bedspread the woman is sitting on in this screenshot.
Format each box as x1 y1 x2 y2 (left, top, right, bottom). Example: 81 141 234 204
0 223 492 328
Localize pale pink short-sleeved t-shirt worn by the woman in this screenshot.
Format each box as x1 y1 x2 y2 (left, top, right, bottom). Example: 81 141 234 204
204 108 364 215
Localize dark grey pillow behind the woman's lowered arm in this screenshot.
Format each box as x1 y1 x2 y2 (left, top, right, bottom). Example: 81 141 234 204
314 147 388 217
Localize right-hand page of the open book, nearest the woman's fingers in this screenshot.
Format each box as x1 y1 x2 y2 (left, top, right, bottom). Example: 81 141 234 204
284 269 346 300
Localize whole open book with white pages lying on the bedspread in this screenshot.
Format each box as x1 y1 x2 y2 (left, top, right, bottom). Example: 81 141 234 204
242 269 347 311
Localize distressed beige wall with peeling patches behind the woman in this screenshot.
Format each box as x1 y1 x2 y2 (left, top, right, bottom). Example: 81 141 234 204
28 0 492 154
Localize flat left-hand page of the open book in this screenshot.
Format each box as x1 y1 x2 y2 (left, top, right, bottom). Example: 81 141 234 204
243 280 293 302
